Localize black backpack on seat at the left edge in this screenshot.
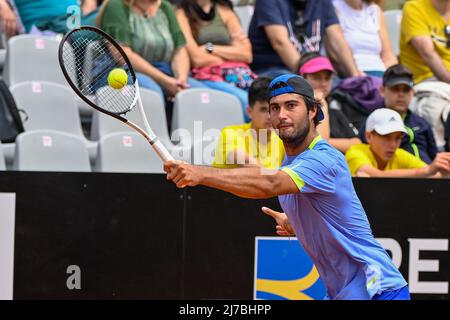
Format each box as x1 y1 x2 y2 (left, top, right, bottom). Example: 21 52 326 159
0 80 24 143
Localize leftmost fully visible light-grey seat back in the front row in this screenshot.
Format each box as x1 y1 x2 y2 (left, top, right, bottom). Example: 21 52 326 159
13 130 91 172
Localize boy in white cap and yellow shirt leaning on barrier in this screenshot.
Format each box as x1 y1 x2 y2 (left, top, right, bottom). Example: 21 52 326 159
345 108 450 178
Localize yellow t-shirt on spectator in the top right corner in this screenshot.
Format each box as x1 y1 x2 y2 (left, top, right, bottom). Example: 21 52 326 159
400 0 450 83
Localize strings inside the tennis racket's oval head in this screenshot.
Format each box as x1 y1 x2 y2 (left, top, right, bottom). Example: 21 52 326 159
62 29 136 114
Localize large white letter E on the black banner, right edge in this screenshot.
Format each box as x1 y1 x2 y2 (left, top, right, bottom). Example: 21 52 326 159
408 239 448 294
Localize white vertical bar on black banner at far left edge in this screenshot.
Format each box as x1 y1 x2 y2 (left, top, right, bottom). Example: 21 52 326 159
0 193 16 300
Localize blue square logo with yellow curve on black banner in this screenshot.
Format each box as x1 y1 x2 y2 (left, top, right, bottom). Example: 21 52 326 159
254 237 326 300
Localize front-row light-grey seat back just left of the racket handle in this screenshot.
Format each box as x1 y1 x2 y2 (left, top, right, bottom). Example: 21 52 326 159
96 132 164 173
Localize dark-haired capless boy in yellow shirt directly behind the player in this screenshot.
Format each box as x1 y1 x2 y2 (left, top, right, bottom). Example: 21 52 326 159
213 77 284 169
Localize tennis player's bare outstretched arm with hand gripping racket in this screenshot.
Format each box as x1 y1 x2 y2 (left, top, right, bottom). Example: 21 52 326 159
164 160 299 199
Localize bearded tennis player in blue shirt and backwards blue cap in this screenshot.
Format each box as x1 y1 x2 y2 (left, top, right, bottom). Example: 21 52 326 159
164 74 410 300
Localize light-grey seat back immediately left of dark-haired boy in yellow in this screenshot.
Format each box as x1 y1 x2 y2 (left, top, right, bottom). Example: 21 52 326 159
172 89 244 164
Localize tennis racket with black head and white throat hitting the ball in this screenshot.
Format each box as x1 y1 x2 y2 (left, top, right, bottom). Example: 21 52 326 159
58 26 173 161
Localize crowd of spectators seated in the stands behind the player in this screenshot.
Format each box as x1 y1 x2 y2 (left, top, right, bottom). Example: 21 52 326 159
0 0 450 177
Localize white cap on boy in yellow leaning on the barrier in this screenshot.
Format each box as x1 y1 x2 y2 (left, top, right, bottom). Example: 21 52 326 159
366 108 408 136
